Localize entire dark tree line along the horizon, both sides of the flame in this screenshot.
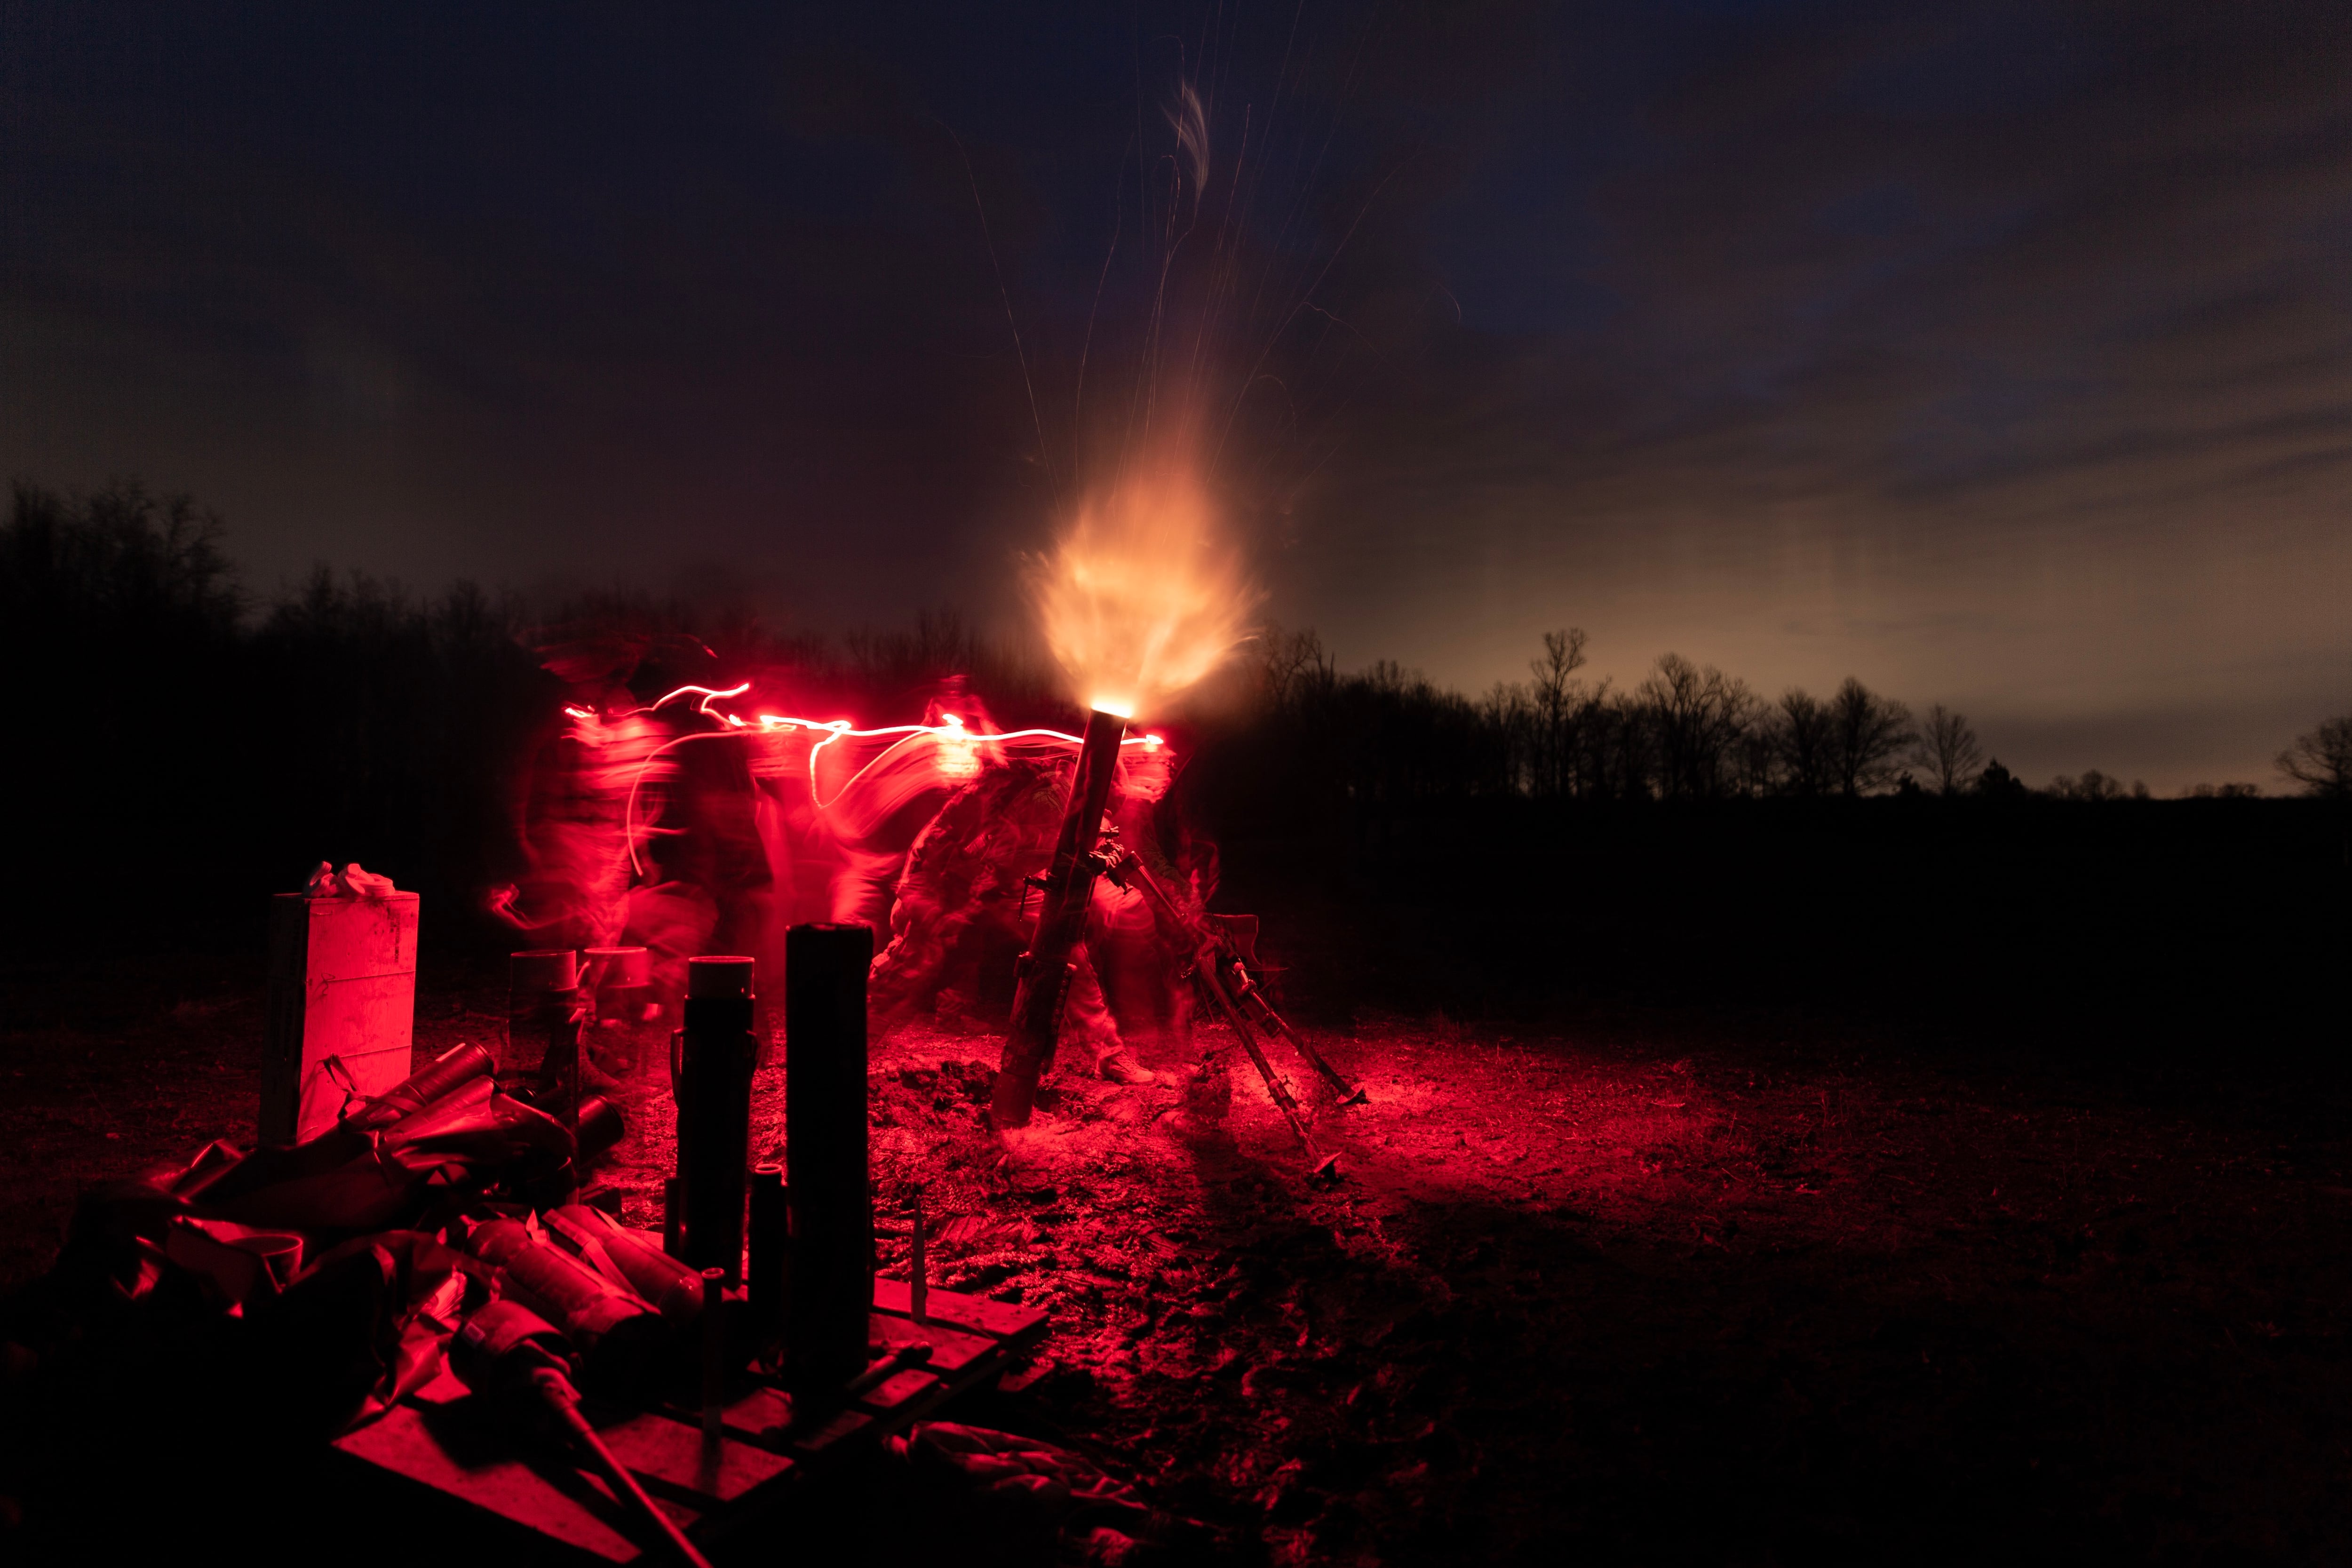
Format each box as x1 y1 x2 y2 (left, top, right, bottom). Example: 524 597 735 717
0 484 2352 931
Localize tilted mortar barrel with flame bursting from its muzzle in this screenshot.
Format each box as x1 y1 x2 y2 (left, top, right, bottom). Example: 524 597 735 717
990 708 1127 1126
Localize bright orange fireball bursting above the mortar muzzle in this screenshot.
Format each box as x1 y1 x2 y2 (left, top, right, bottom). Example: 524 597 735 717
1030 470 1258 717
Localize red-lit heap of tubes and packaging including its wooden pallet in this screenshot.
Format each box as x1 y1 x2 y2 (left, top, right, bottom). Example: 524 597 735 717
39 896 1047 1563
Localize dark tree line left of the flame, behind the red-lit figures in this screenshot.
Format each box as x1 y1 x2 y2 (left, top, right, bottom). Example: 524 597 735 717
0 482 1068 943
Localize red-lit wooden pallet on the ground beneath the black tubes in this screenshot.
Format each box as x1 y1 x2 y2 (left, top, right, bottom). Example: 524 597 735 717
334 1279 1047 1563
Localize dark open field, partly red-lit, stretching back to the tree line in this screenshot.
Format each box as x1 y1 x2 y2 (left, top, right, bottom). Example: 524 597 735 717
0 802 2352 1563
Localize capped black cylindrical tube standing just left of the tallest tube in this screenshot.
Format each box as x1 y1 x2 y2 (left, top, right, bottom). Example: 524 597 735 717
677 957 760 1279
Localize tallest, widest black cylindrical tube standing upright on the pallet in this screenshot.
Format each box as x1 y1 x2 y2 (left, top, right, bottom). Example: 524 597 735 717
783 926 875 1399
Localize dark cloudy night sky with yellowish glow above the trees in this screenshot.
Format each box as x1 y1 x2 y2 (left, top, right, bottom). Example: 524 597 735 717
0 0 2352 792
